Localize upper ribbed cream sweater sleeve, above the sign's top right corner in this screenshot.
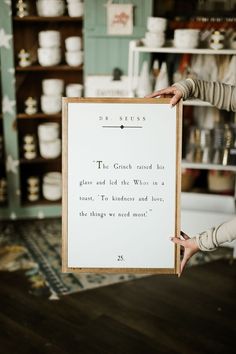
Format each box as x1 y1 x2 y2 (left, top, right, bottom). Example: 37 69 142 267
173 78 236 112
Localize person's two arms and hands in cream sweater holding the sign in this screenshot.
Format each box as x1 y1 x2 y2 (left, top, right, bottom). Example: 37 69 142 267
147 78 236 272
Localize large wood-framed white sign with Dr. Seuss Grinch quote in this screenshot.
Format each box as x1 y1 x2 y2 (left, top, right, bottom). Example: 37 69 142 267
62 98 182 274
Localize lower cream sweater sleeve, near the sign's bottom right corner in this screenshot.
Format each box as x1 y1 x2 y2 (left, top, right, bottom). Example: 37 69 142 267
195 217 236 251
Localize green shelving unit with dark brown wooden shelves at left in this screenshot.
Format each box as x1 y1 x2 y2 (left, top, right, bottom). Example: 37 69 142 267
0 0 84 219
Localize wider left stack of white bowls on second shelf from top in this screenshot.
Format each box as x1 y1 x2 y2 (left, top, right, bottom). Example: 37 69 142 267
38 31 61 66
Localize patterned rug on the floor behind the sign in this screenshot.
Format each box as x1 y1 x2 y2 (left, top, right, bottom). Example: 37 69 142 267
0 219 232 299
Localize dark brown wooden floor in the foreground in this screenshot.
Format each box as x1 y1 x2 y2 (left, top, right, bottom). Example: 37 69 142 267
0 261 236 354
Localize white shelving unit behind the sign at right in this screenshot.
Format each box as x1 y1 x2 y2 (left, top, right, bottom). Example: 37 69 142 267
129 41 236 252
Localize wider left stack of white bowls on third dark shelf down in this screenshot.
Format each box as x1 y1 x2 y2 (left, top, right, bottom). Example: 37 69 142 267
41 79 64 114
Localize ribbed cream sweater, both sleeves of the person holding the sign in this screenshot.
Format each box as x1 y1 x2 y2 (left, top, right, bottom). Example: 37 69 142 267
173 79 236 251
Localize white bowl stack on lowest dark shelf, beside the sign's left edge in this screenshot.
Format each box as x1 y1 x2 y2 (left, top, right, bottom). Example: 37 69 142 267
42 172 62 201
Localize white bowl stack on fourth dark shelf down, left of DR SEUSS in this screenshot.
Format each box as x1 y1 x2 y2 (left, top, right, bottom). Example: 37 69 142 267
38 122 61 159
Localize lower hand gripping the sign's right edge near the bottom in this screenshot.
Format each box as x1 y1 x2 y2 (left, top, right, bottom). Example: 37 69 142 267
171 231 199 274
